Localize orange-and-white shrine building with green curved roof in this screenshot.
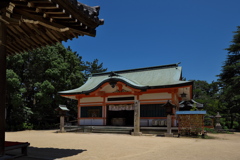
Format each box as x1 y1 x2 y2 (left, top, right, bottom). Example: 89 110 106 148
59 64 193 127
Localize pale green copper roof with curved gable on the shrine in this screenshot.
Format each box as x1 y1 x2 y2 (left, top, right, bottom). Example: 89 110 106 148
59 64 192 95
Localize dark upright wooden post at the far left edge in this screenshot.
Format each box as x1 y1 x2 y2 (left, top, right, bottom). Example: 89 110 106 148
0 21 7 157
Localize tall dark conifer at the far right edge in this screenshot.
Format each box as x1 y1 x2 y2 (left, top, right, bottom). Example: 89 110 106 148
218 26 240 128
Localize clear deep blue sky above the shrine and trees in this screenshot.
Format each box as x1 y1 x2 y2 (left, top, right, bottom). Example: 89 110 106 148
63 0 240 83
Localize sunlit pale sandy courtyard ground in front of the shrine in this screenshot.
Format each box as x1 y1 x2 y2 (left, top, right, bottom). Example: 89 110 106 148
6 130 240 160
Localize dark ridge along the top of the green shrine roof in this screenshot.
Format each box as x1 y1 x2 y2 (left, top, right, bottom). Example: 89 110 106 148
92 62 180 77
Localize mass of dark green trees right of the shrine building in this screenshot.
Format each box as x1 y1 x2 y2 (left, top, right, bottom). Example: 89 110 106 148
193 27 240 129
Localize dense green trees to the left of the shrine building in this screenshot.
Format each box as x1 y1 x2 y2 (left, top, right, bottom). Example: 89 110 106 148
6 44 106 130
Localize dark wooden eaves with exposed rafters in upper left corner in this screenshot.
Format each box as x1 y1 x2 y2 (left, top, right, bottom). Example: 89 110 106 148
0 0 103 55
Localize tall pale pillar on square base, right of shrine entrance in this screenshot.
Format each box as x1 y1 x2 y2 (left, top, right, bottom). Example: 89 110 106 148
132 100 142 136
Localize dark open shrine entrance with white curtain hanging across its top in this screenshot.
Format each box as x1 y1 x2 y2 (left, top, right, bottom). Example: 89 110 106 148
106 105 134 126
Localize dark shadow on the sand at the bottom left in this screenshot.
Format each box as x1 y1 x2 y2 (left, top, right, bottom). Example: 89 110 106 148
7 146 87 160
